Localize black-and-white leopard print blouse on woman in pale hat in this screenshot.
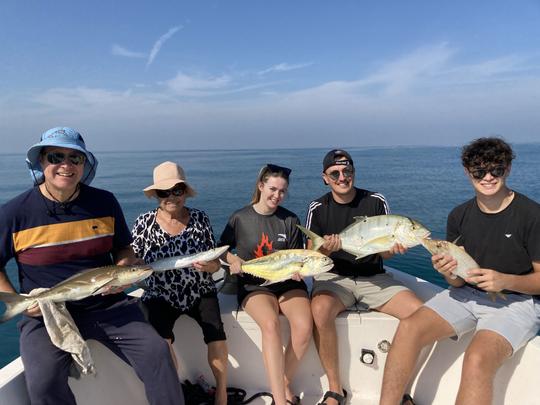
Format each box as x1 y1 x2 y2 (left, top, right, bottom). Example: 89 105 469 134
131 207 216 311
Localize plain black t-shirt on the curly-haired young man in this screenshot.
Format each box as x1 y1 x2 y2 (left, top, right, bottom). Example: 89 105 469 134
446 192 540 274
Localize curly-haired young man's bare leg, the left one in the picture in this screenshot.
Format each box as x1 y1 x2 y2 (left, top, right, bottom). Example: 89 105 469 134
380 306 455 405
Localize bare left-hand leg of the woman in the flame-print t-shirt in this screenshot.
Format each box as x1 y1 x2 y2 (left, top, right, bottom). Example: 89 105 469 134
244 292 287 405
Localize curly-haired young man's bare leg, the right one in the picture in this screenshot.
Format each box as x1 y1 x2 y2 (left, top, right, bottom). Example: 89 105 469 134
456 330 512 405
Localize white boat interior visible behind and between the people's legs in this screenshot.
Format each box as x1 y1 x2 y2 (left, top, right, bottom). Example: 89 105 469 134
0 266 540 405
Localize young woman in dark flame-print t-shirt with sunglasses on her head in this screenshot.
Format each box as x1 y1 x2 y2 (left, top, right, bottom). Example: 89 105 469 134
220 164 313 405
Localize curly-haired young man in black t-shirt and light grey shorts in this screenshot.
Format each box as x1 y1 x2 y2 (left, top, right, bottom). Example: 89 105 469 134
380 137 540 405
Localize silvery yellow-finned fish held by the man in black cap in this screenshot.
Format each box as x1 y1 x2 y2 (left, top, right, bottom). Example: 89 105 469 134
297 215 430 259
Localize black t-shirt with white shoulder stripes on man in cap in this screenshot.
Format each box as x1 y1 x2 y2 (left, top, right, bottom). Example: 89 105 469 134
306 188 390 276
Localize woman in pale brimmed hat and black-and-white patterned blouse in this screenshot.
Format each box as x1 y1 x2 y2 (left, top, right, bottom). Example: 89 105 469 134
132 162 227 405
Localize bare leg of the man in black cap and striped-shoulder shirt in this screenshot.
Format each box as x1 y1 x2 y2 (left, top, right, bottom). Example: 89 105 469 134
311 292 346 405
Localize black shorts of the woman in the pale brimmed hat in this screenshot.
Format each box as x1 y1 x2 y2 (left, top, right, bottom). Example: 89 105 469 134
142 294 227 344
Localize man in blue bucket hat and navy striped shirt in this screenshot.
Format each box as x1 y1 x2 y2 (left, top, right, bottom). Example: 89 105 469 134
0 127 184 405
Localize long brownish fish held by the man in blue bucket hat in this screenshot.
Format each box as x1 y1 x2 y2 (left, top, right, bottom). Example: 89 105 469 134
0 265 152 323
